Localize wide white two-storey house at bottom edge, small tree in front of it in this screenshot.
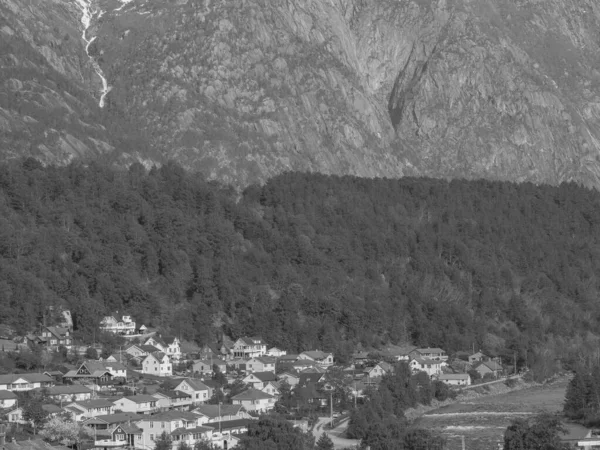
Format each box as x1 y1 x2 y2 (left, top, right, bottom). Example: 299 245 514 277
136 411 213 449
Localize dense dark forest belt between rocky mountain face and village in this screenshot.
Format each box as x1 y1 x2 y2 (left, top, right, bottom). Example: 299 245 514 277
0 159 600 371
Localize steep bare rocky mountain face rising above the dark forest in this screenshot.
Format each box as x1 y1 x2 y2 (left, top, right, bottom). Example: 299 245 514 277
0 0 600 187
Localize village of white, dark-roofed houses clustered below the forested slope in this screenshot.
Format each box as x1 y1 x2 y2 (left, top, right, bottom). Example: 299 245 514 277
0 314 510 450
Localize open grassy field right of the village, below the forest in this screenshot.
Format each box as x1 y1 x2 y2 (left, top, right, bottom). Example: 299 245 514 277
417 379 568 450
